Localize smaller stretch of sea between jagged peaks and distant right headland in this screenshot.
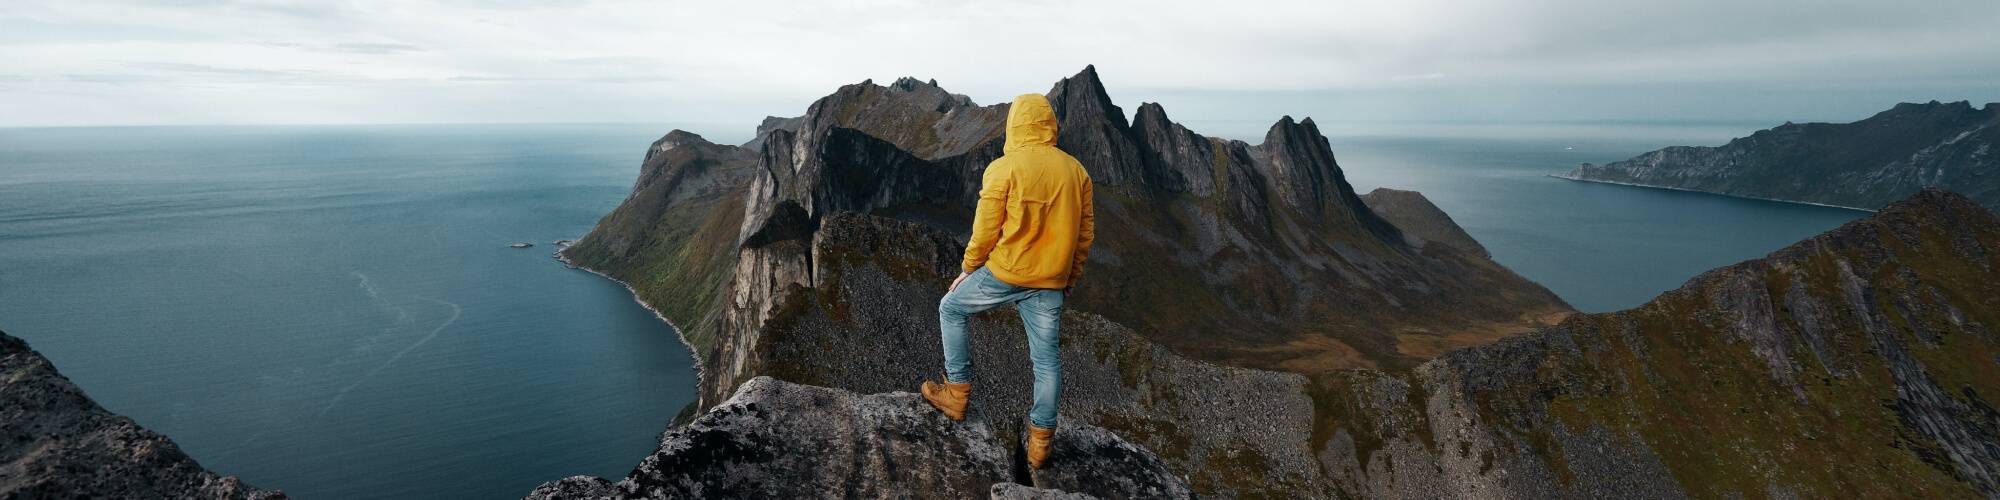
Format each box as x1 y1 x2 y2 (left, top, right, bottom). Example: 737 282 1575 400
1328 122 1868 312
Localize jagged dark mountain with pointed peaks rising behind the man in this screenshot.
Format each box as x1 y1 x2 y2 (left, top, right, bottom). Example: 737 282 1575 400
564 68 1570 386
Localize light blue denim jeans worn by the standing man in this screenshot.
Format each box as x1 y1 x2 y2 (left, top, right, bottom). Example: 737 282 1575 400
938 268 1062 428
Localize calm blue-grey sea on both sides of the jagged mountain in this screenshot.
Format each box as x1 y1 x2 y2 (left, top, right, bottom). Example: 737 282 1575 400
0 124 1864 498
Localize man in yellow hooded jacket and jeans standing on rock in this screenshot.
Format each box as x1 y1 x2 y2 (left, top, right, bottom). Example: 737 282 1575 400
924 94 1094 468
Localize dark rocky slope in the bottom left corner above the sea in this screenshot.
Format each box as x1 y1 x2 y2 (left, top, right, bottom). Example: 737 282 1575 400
0 332 284 498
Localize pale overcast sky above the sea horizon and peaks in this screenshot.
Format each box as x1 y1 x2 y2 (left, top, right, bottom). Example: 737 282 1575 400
0 0 2000 126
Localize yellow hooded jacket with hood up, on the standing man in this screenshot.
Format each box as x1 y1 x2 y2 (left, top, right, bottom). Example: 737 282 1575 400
964 94 1096 288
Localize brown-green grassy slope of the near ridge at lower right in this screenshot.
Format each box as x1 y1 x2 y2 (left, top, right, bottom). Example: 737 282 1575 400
1312 190 2000 498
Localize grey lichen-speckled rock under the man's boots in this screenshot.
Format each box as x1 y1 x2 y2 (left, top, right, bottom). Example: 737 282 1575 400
530 378 1188 498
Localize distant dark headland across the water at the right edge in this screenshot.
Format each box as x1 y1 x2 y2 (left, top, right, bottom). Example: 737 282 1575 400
1560 100 2000 210
